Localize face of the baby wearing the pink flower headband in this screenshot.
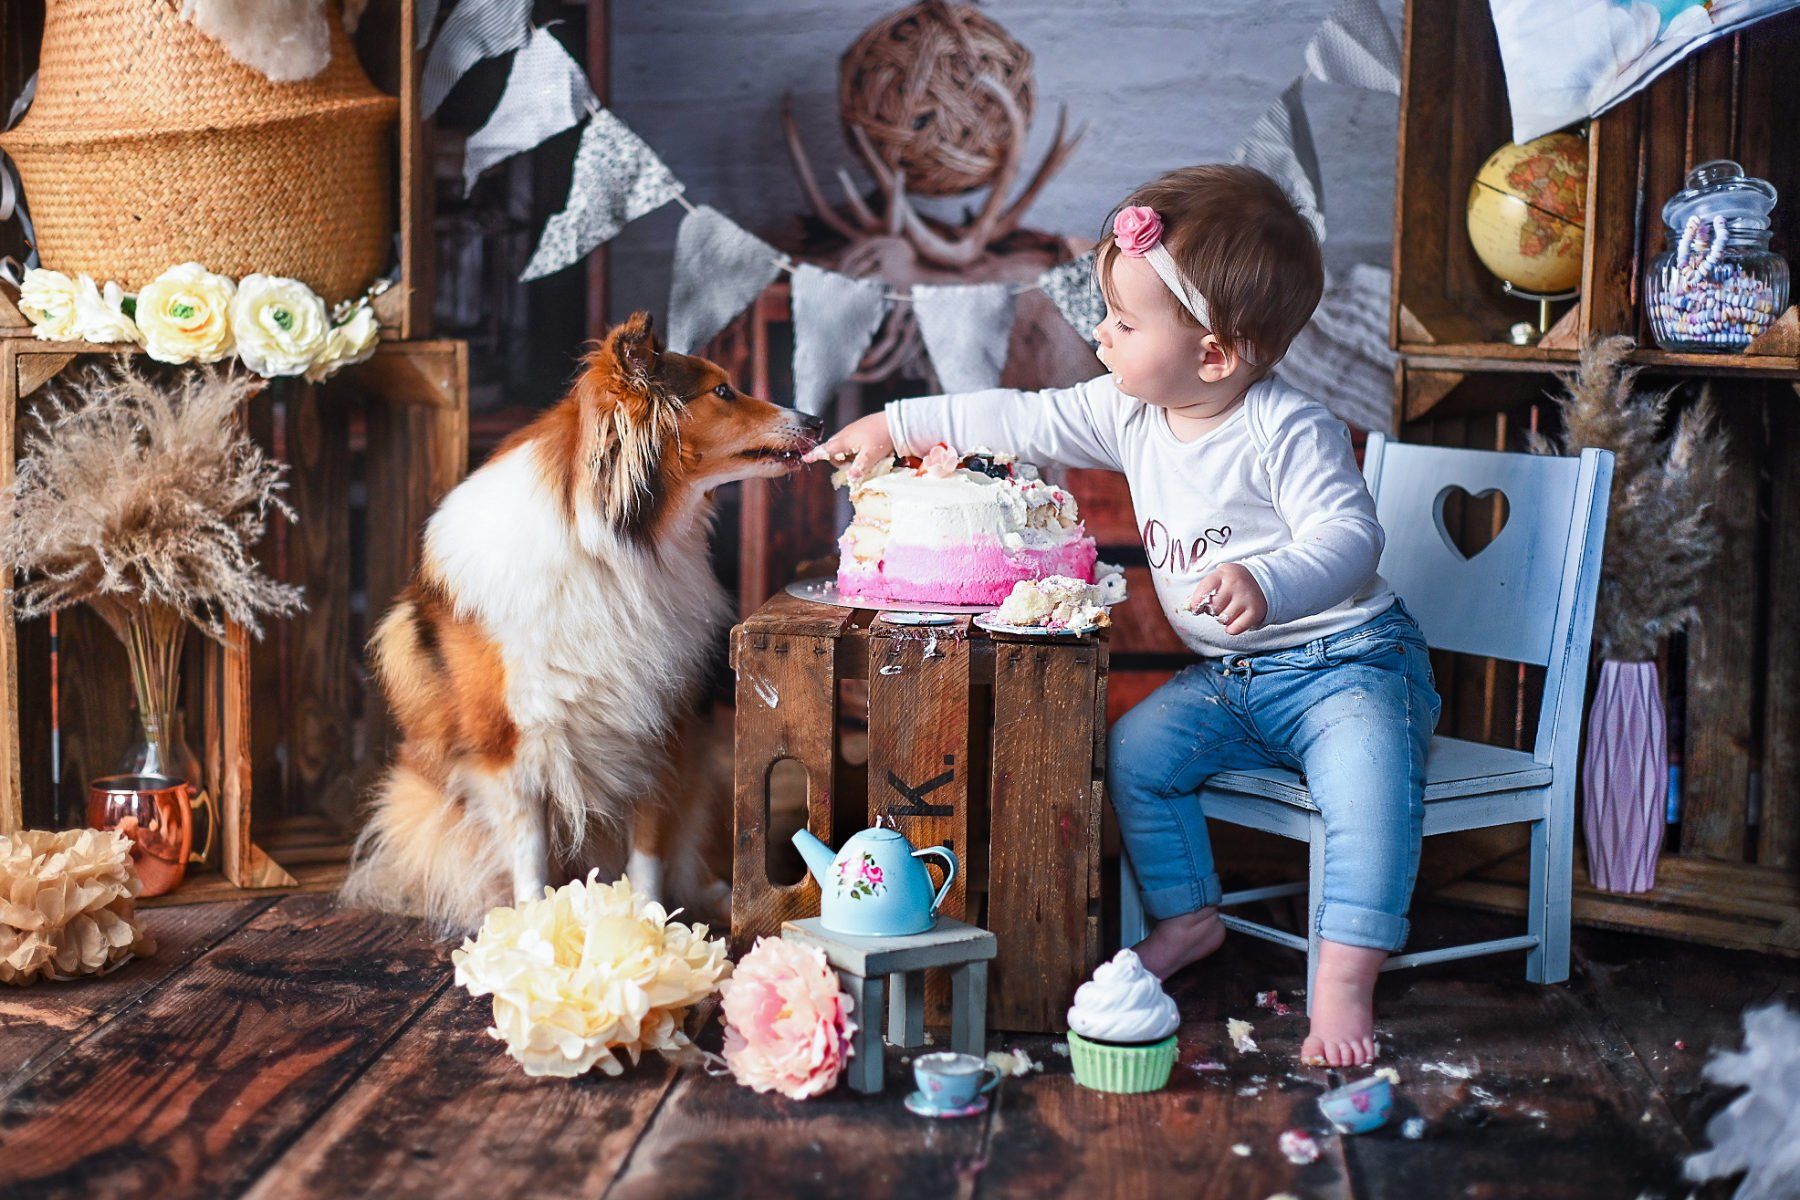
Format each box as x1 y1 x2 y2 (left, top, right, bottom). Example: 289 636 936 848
1094 254 1206 408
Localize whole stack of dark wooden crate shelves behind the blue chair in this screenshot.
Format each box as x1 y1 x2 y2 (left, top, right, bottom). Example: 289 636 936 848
1391 0 1800 954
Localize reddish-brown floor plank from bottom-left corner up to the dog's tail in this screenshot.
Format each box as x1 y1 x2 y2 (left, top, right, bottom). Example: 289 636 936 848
0 896 448 1200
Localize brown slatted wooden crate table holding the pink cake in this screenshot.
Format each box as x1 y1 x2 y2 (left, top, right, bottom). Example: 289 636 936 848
731 594 1107 1033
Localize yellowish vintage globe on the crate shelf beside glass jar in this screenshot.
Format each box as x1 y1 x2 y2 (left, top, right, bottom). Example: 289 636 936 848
1469 133 1588 293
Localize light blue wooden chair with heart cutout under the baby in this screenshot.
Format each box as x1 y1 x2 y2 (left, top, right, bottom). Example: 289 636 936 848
1120 434 1613 995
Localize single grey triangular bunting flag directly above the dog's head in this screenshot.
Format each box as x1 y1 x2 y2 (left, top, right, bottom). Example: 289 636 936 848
668 205 781 354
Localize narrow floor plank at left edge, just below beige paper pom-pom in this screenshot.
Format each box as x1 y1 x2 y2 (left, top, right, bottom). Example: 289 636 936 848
0 900 274 1097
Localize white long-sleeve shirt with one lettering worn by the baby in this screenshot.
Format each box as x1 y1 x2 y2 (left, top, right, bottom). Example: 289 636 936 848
887 374 1393 657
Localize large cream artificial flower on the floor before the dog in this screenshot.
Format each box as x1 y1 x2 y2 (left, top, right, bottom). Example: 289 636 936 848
450 871 731 1076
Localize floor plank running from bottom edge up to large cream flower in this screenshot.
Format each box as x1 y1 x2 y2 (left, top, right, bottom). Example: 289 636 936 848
245 988 675 1200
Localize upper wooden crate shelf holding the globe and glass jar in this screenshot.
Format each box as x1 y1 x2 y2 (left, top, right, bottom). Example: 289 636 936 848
1390 0 1800 368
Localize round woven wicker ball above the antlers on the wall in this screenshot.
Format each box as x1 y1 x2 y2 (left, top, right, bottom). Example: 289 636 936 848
837 0 1035 196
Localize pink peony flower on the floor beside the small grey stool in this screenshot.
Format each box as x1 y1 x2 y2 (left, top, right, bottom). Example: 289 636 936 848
718 937 857 1099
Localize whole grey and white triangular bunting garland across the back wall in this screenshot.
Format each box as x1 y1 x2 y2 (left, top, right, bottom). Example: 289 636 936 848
397 0 1400 390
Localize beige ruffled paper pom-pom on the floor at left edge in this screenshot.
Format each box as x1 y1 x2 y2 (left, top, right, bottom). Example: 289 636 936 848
0 829 157 984
